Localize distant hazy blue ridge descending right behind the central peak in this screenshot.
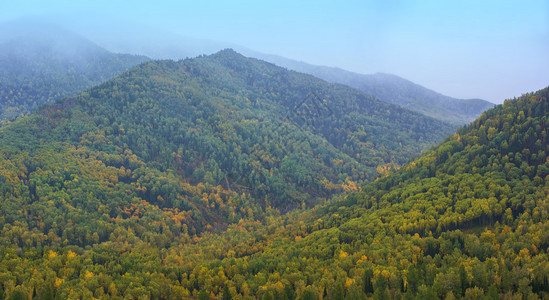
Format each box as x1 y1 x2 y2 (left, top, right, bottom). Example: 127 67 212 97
243 50 494 126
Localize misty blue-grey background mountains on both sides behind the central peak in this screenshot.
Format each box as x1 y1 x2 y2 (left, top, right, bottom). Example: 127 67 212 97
0 18 493 127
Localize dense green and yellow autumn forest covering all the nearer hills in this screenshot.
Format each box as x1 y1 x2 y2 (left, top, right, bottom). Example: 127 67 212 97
0 50 549 299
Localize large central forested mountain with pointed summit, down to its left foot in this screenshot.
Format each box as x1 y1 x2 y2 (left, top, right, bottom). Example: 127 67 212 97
0 50 452 298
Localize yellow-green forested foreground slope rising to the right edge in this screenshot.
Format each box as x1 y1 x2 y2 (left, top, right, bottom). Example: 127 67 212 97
173 88 549 299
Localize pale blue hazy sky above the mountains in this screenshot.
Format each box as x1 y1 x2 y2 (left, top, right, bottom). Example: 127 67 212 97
0 0 549 103
